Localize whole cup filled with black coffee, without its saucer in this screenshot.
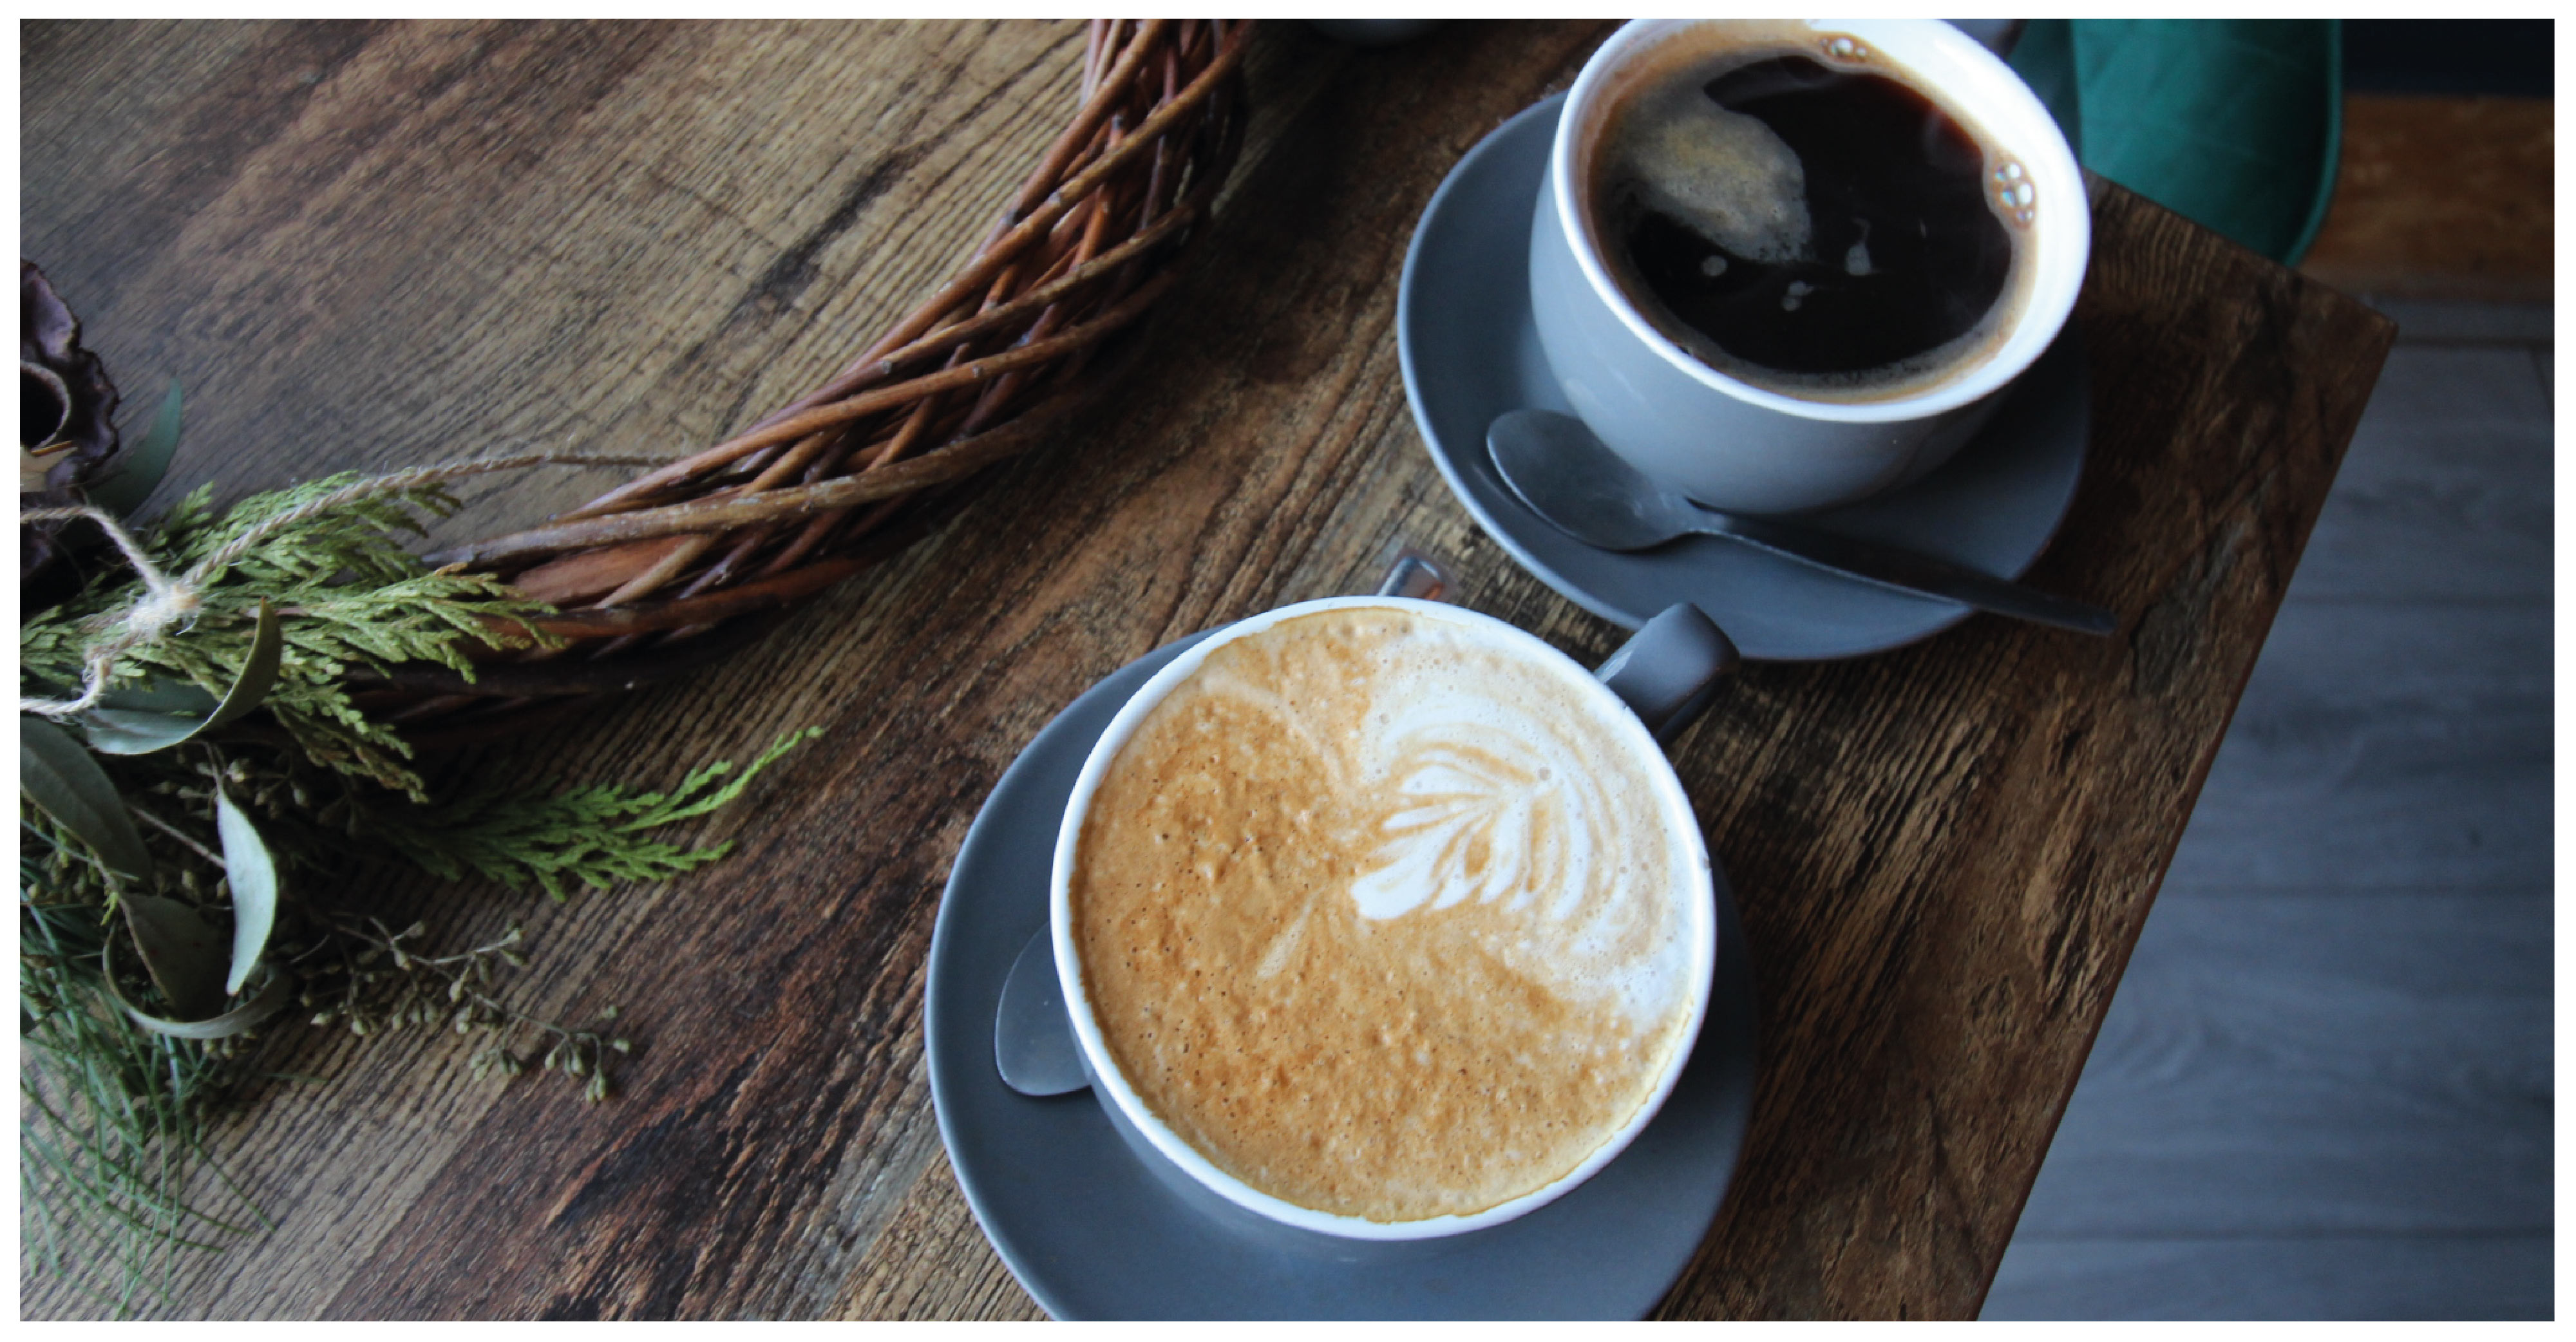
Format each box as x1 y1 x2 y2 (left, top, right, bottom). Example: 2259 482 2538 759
1530 21 2092 513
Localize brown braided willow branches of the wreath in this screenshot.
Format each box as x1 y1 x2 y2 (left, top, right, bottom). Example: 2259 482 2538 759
389 18 1252 729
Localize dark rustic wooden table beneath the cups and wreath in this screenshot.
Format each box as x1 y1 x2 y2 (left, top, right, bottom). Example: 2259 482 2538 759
21 23 2391 1316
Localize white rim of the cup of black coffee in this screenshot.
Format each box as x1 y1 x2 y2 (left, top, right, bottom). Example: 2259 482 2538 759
1548 18 2092 425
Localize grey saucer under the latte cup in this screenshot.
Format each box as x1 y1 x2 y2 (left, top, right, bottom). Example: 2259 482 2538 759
922 636 1754 1319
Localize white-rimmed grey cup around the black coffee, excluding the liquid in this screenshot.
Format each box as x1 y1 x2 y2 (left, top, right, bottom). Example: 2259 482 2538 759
1530 18 2092 513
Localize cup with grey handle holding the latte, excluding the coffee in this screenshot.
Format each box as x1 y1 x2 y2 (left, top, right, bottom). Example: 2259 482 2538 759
1048 595 1734 1242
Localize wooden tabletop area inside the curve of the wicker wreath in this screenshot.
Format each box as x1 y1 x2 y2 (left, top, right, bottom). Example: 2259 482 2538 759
23 23 1118 536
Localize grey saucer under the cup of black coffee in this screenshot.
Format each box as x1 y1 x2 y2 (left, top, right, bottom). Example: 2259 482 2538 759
1396 95 2089 662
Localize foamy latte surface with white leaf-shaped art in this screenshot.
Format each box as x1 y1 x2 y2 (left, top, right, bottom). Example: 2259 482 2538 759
1069 608 1703 1221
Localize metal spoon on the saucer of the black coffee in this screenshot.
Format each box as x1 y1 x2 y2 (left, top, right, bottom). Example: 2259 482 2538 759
1484 410 2120 634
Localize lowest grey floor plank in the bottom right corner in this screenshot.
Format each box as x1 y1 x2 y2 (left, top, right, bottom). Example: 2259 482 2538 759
1981 1234 2558 1321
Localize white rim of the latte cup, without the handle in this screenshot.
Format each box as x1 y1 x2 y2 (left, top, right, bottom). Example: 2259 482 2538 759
1046 595 1718 1239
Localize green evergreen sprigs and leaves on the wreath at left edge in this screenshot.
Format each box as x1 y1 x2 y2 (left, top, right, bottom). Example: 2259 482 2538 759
18 474 817 1311
